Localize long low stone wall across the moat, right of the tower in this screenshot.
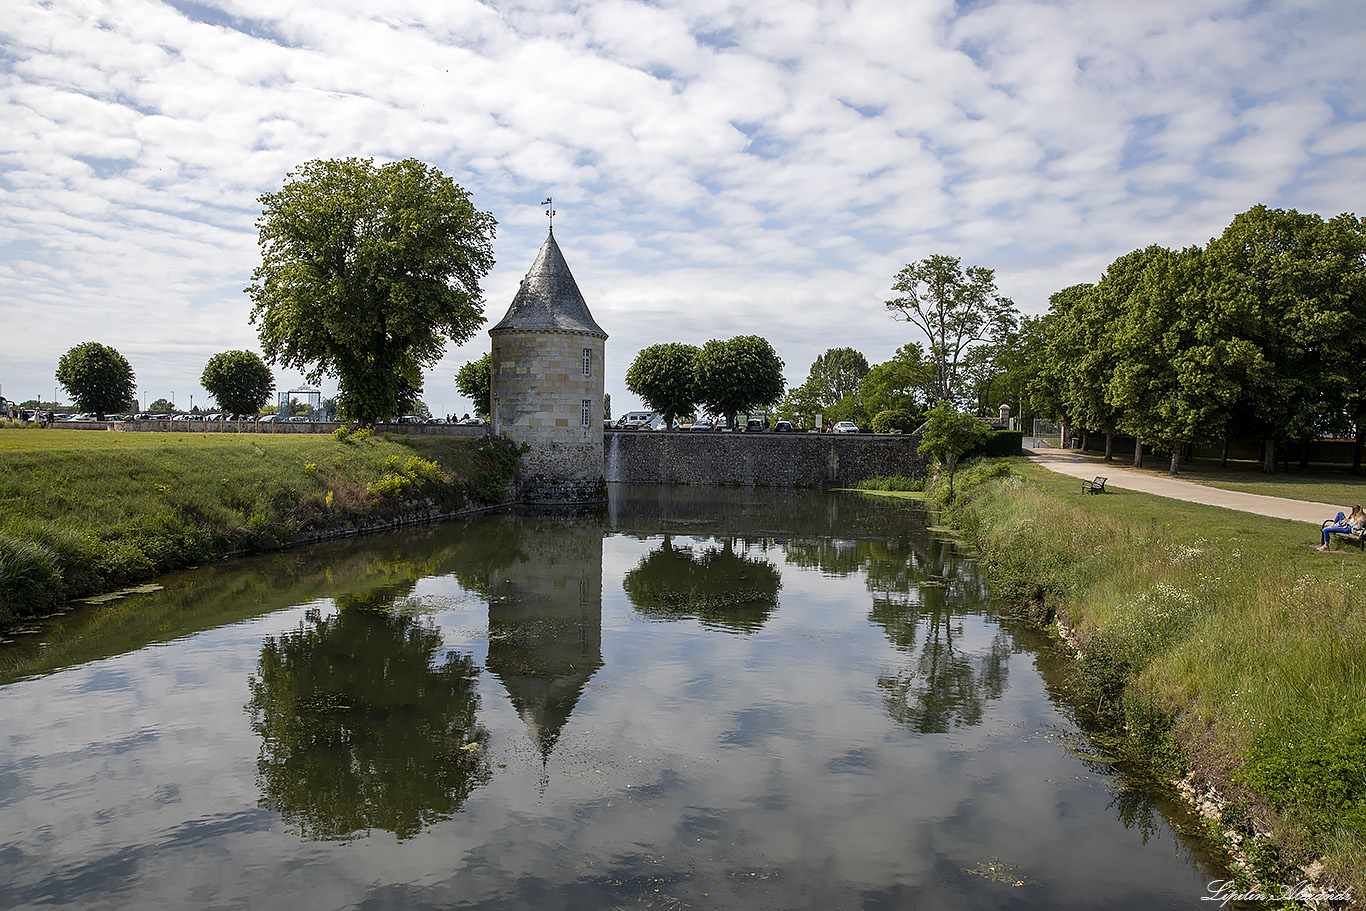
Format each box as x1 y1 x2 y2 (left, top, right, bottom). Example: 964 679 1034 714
605 430 926 488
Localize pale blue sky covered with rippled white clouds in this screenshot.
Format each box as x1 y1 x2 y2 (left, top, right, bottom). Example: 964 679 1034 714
0 0 1366 414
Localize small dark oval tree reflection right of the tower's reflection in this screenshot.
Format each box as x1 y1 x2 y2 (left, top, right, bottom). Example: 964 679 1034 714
622 534 783 632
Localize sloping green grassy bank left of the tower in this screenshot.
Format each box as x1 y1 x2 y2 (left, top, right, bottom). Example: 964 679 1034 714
0 429 516 628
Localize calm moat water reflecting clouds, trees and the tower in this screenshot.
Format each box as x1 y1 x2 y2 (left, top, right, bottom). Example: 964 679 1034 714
0 485 1225 911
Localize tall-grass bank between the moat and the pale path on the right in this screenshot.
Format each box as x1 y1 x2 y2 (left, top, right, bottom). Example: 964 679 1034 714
930 459 1366 899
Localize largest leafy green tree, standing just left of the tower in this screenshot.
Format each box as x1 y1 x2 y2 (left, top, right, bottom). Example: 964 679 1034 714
247 158 496 422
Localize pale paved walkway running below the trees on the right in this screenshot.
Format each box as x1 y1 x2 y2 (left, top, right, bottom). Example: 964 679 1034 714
1025 449 1343 526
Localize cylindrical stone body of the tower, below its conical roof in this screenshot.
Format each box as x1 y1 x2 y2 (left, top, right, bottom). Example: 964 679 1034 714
490 331 605 503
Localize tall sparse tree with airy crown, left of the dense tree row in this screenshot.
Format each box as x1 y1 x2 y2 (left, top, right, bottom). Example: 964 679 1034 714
887 254 1016 402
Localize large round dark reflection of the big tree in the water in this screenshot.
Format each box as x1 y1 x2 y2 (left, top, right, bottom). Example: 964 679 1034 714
246 590 489 840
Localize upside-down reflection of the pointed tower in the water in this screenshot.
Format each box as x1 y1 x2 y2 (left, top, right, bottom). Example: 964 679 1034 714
486 516 602 763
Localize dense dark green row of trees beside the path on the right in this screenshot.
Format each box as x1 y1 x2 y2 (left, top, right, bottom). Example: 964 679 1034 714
1030 206 1366 474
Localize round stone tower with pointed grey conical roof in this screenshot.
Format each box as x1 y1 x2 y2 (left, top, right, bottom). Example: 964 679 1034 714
489 229 607 504
